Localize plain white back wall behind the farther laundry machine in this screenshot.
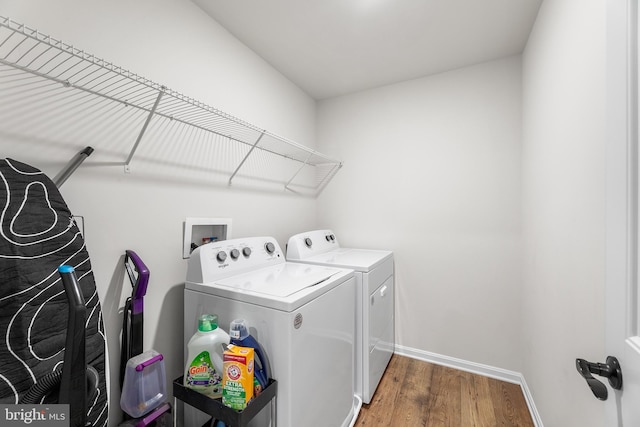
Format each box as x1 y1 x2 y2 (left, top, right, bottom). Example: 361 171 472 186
316 56 522 371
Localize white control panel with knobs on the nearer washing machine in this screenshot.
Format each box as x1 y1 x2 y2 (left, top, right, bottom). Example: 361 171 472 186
187 237 286 283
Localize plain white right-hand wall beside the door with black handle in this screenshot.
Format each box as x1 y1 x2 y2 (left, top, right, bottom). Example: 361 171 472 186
522 0 606 427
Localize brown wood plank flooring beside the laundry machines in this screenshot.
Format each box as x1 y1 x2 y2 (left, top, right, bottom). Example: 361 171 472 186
355 355 534 427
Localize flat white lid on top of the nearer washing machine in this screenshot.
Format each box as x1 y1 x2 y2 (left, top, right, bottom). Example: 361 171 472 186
216 263 340 298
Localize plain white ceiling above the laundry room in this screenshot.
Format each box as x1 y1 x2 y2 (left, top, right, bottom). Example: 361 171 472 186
193 0 542 100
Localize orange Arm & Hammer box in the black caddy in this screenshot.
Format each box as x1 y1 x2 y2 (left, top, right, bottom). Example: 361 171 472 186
222 344 254 410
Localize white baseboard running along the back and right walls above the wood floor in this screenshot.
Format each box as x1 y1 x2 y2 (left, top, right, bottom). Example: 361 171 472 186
395 344 544 427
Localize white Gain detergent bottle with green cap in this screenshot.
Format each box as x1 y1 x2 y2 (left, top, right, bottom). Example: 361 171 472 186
184 314 230 397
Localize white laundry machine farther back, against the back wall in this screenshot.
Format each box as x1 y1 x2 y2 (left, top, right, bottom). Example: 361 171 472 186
287 230 395 403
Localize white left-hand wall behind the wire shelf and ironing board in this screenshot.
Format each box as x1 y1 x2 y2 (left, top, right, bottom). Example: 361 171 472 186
0 0 316 425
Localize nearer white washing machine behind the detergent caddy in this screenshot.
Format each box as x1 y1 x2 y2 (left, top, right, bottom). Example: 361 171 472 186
184 237 361 427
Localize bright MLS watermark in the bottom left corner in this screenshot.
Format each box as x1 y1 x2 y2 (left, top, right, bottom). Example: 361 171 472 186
0 404 69 427
